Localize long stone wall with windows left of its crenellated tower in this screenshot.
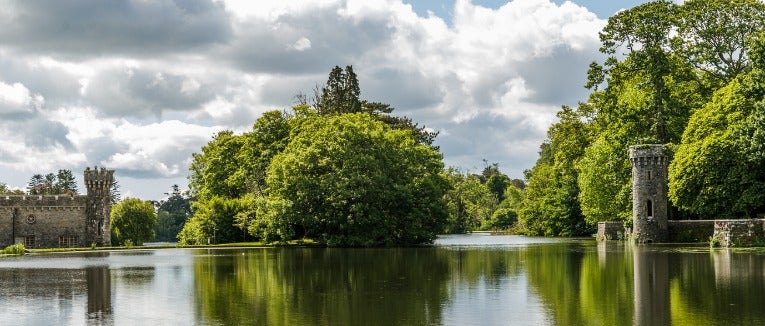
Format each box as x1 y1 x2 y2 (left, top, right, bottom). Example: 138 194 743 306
0 195 90 248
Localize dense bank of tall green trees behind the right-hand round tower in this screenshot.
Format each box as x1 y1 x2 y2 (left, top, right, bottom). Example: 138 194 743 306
519 0 765 235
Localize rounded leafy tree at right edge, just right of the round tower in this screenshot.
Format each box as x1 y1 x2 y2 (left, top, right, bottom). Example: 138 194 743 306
669 33 765 218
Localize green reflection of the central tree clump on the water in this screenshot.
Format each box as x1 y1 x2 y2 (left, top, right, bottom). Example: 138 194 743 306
194 248 449 325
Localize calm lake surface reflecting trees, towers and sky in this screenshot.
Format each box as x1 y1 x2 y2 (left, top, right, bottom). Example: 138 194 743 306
0 234 765 325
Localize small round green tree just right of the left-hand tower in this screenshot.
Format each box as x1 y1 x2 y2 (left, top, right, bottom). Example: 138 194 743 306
111 198 157 246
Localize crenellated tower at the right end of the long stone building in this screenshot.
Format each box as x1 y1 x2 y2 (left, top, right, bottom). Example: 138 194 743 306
84 167 114 246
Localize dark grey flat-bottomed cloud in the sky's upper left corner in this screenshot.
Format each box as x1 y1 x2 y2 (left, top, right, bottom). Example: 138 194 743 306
0 0 231 59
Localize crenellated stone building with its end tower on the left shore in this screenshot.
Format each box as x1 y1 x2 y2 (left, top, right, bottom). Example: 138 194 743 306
0 168 114 248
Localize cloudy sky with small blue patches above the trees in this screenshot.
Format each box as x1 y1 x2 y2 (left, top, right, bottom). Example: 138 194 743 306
0 0 644 199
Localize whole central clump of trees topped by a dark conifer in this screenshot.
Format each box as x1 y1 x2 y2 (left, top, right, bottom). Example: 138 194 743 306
178 67 448 246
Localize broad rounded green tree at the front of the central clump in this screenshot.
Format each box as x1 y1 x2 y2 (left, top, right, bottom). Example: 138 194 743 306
250 113 447 246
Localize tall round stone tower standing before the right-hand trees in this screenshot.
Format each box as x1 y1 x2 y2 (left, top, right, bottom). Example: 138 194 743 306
630 145 669 243
